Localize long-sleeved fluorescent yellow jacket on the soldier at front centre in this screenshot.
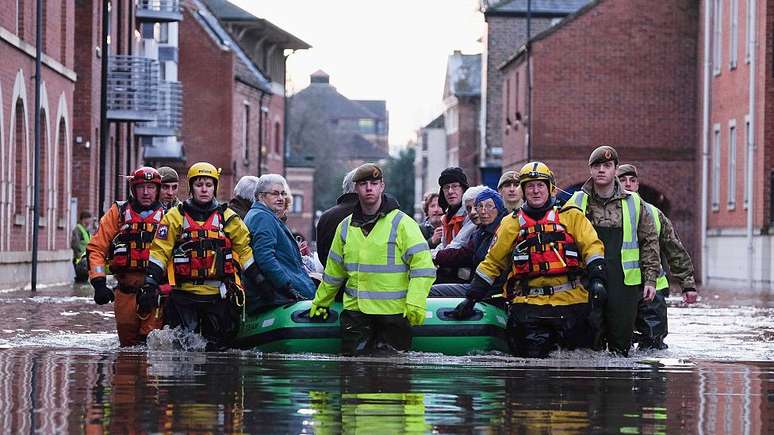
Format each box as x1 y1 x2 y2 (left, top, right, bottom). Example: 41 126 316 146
315 210 435 314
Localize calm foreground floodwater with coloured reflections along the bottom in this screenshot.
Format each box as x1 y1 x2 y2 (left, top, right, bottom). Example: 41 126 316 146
0 349 774 434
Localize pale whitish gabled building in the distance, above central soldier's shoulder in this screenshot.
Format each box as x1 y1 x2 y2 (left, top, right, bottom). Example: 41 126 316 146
414 115 450 217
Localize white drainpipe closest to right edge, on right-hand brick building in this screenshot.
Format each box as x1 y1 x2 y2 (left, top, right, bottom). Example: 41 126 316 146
746 0 758 289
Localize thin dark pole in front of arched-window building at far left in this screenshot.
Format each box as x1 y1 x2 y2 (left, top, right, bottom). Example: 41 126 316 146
30 0 43 293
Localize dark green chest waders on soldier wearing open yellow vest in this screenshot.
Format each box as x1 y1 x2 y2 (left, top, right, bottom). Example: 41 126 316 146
594 226 642 356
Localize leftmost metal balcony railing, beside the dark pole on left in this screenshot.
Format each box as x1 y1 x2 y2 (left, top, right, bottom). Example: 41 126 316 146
107 55 159 121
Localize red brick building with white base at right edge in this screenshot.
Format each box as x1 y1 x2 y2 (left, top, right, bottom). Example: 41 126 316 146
695 0 774 289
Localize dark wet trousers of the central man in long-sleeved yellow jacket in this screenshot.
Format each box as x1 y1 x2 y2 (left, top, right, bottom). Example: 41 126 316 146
341 310 411 356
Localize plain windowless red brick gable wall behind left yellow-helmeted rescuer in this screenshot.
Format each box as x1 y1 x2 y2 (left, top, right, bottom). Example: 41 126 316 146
179 4 233 200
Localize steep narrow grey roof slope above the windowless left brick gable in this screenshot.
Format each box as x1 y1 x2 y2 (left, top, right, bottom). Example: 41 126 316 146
191 0 271 92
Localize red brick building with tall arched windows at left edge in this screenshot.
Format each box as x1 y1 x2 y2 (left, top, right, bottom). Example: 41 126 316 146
0 0 77 288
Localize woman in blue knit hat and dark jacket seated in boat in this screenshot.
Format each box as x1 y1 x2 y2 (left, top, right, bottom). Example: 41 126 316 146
430 187 508 298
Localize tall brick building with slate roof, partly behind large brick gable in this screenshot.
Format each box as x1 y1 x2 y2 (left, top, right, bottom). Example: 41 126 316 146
480 0 589 185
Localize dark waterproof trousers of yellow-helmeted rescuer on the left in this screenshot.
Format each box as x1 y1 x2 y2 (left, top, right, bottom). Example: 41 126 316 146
164 289 239 350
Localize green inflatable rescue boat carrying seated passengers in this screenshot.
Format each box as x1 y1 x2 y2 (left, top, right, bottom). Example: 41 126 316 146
236 298 508 355
